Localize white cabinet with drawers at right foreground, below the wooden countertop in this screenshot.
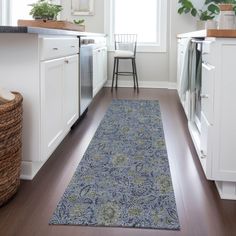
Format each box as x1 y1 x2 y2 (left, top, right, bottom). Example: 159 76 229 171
177 38 236 200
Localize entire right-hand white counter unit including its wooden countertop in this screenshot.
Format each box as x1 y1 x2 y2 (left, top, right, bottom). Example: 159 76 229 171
177 30 236 200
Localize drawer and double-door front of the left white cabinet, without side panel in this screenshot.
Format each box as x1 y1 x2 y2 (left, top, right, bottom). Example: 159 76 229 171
40 37 79 167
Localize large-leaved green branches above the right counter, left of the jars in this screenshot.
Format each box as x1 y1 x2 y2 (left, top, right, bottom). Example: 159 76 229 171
178 0 220 21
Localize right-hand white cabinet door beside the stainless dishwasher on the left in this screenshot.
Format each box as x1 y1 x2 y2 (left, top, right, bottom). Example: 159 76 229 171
63 55 79 131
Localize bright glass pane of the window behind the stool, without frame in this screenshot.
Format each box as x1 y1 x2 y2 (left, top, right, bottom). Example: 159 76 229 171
114 0 159 43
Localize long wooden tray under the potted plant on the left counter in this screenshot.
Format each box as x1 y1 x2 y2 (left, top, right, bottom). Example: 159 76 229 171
18 20 85 32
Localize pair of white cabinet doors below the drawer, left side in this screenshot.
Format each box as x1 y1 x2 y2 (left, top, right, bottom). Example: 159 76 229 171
41 55 79 161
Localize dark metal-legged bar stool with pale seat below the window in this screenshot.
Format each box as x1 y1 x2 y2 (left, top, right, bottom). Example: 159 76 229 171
111 34 139 91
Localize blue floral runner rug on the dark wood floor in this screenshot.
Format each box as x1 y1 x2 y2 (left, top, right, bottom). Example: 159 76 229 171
50 100 180 230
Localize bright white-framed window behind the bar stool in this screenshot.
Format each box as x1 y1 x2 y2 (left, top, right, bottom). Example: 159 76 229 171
105 0 167 52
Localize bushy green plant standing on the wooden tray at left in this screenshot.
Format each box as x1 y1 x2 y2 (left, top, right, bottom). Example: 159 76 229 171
30 0 63 20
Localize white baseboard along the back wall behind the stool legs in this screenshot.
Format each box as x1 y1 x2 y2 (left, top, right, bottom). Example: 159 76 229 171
104 80 177 90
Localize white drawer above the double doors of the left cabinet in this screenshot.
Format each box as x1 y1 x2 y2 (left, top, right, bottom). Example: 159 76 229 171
40 37 79 61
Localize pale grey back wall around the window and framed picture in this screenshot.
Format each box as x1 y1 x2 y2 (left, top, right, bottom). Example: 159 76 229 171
61 0 204 86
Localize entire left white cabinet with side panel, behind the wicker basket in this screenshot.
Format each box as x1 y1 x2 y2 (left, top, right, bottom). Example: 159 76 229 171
0 33 79 179
